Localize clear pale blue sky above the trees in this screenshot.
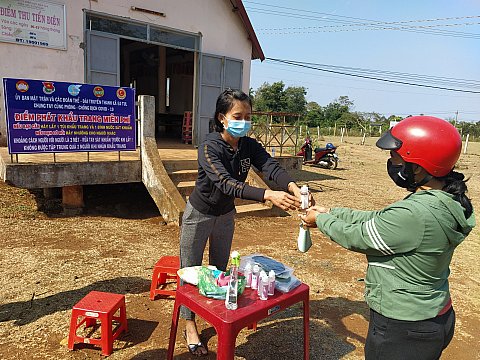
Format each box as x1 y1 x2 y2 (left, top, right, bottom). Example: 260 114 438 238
243 0 480 122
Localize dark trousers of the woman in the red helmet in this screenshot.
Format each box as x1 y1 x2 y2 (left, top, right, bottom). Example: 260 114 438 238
365 308 455 360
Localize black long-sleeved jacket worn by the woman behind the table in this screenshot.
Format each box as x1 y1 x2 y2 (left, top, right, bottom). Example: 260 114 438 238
189 132 293 216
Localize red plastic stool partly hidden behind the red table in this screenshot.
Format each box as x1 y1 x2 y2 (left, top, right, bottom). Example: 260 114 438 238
150 256 180 300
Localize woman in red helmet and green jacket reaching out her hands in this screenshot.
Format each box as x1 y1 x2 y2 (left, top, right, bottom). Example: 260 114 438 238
302 116 475 360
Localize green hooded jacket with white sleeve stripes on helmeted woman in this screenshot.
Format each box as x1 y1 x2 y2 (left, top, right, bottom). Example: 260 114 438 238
316 190 475 321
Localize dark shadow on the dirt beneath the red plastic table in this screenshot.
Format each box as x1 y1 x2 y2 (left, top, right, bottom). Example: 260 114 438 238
159 297 369 360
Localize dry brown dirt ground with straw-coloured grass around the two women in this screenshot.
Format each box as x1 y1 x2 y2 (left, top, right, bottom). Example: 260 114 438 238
0 140 480 360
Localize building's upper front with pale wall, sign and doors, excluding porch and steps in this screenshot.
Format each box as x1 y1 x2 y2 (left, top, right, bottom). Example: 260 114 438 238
0 0 264 146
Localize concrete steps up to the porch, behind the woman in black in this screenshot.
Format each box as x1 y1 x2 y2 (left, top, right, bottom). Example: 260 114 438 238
163 160 274 217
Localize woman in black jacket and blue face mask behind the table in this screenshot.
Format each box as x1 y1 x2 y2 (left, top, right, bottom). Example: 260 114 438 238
180 89 300 356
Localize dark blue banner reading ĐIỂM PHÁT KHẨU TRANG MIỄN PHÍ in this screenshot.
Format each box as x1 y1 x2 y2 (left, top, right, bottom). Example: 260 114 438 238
3 78 136 154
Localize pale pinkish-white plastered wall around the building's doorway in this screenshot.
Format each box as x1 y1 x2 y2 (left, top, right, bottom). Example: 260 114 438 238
0 0 252 145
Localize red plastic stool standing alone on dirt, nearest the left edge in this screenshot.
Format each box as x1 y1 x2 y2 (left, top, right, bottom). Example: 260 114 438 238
68 291 128 356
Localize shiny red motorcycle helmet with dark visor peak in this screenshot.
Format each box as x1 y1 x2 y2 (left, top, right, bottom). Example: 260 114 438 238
377 116 462 177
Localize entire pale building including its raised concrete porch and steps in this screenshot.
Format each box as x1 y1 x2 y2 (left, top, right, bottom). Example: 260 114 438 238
0 0 282 223
